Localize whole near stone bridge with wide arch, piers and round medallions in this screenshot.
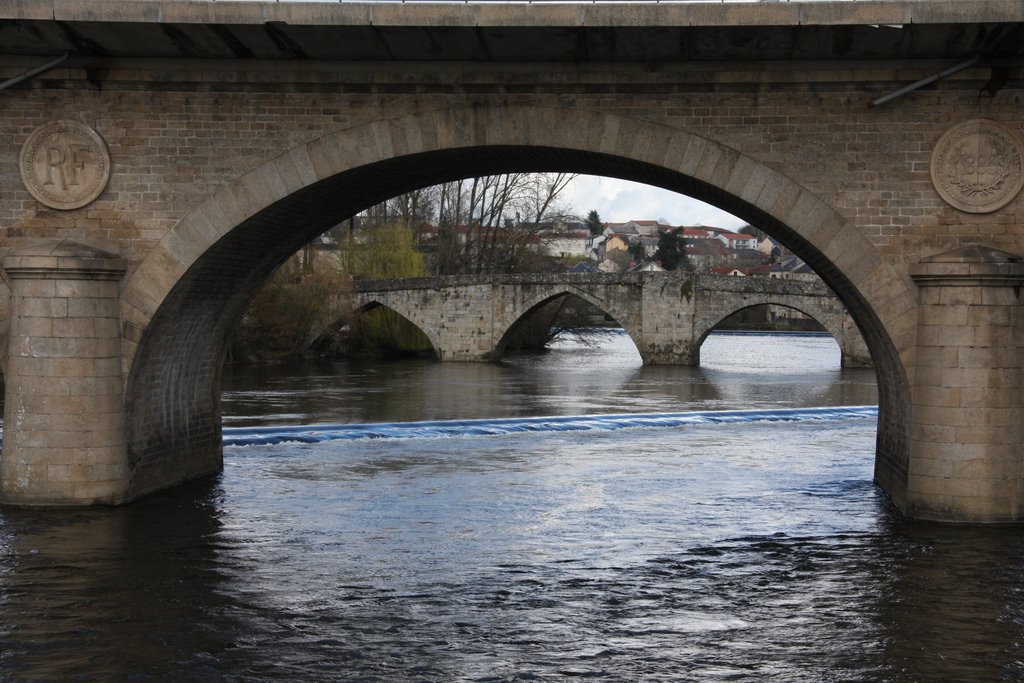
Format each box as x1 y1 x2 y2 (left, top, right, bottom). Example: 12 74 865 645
0 0 1024 521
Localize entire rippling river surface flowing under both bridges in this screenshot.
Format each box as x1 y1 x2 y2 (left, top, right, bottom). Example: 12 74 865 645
0 332 1024 681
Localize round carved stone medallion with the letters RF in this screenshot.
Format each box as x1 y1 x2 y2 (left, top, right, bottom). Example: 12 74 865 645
18 121 111 210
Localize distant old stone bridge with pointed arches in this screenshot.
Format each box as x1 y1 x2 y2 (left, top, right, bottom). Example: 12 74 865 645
355 272 870 367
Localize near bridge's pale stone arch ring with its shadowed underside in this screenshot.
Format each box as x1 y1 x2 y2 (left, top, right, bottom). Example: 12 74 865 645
122 104 916 507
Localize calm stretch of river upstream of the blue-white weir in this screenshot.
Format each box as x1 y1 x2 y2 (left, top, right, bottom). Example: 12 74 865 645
223 330 878 426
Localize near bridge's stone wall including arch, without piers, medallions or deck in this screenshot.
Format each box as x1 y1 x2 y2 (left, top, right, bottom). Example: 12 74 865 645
0 22 1024 518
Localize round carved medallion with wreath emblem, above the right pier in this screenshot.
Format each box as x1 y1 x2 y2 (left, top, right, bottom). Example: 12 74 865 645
931 119 1024 213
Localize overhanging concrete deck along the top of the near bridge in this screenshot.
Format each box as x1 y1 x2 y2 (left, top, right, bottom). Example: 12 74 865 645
8 0 1024 65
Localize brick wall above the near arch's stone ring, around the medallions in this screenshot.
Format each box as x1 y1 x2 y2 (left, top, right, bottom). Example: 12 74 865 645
0 59 1024 278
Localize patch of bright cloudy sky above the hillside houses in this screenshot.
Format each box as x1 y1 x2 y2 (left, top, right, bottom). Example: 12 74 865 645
564 175 746 229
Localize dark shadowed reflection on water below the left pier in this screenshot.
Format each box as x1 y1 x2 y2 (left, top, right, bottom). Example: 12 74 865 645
0 481 238 681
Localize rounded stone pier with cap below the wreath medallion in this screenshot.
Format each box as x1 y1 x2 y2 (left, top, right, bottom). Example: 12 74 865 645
906 245 1024 522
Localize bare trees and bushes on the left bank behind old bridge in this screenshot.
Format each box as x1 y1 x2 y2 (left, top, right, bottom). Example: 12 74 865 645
229 173 574 362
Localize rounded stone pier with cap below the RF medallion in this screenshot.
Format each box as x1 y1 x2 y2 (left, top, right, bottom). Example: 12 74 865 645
0 240 127 506
